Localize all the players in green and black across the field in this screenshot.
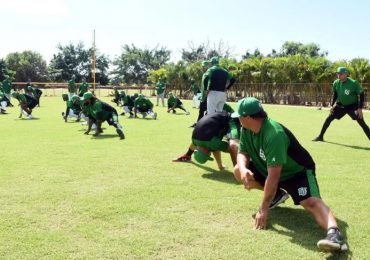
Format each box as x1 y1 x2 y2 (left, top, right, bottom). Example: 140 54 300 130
0 57 370 251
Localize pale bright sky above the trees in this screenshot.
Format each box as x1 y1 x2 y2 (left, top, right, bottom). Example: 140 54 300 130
0 0 370 62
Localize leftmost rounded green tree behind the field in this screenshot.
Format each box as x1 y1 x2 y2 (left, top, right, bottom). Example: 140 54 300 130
5 51 48 82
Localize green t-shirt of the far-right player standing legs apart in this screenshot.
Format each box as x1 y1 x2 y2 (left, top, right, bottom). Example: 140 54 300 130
333 77 363 106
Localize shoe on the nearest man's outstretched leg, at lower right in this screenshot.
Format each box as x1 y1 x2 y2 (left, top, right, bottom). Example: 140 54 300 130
317 228 348 251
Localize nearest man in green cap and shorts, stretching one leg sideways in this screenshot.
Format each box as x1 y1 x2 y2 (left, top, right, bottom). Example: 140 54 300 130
232 97 348 251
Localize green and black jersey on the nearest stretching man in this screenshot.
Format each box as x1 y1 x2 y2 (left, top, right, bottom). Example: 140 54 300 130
239 118 315 181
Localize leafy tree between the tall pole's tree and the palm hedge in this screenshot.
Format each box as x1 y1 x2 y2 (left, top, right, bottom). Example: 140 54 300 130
112 44 171 84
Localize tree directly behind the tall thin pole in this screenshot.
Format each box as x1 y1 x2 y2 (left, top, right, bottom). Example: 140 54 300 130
49 42 110 85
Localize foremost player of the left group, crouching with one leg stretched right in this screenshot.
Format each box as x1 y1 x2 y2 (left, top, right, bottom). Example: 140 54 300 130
83 92 125 139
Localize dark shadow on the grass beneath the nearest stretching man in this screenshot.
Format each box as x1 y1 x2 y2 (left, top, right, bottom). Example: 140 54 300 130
264 207 352 259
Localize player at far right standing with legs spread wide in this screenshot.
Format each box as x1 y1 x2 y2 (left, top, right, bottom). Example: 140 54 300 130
312 67 370 141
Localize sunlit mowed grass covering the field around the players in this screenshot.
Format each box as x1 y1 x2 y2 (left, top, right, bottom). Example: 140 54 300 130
0 97 370 259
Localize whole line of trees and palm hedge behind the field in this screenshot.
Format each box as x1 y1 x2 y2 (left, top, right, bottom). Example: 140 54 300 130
0 41 370 89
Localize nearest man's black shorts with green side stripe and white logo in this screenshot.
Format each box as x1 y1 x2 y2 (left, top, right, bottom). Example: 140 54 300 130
248 162 320 205
